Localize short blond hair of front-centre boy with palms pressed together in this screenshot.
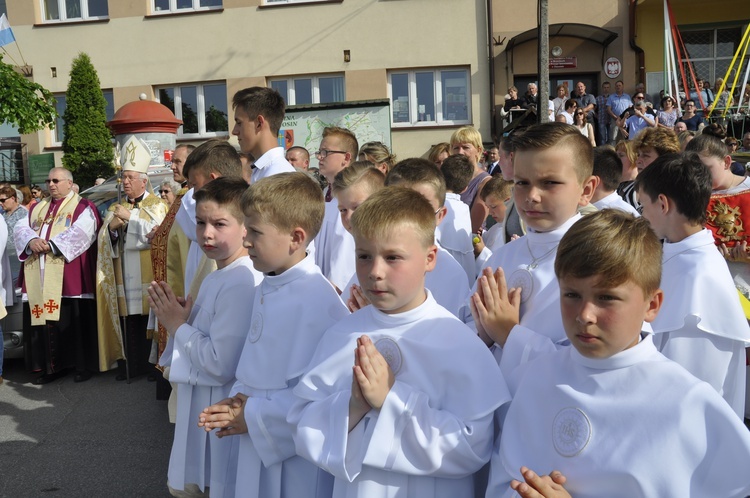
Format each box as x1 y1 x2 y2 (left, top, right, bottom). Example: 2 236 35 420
351 187 435 248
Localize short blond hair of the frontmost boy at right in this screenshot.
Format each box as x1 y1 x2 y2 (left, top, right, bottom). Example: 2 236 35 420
555 209 662 297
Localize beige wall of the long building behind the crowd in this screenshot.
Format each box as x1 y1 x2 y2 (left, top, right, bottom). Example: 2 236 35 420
8 0 490 157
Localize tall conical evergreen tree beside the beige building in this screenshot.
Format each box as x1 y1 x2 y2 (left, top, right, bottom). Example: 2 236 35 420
62 53 114 187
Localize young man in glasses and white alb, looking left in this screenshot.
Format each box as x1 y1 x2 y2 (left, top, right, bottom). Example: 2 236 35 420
315 126 359 293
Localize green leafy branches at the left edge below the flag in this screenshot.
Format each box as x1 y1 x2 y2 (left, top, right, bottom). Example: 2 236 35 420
0 54 57 134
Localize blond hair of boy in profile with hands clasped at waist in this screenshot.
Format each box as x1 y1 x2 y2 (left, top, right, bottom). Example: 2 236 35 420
242 172 325 243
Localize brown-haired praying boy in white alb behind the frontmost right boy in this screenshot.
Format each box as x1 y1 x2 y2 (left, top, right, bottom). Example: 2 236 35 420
470 123 596 370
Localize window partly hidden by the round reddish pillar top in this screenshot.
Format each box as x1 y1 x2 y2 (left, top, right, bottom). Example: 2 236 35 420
156 83 229 138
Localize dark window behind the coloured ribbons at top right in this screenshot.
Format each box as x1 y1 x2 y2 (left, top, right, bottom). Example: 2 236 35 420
680 26 748 87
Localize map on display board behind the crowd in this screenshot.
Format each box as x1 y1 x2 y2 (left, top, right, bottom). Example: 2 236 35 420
279 101 391 168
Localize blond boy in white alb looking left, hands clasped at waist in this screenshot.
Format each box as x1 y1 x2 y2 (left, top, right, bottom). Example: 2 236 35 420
198 173 349 498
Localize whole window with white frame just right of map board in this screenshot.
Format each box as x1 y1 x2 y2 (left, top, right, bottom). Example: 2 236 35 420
388 69 471 127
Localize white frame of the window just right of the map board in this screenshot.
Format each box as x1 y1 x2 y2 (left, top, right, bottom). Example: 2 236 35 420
388 67 472 128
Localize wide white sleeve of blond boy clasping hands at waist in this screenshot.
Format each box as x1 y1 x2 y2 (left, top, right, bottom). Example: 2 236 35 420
245 379 299 467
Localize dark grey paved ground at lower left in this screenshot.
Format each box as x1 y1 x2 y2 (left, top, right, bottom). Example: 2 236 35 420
0 360 174 498
